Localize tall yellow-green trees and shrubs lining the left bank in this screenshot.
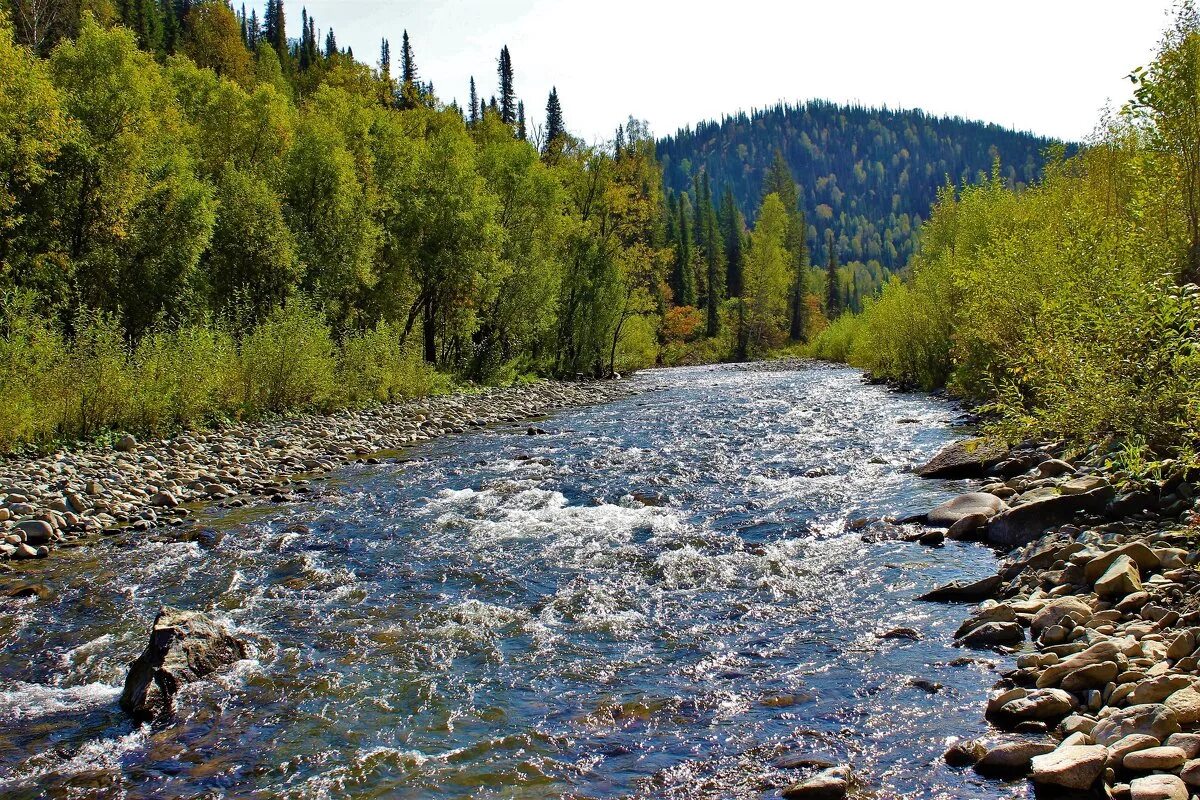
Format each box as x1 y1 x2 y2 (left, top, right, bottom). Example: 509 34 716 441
0 0 670 447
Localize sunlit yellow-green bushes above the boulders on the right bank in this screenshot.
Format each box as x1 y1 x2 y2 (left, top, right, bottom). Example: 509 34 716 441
815 4 1200 471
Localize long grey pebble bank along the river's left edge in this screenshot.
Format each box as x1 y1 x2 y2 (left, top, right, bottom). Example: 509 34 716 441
0 381 630 571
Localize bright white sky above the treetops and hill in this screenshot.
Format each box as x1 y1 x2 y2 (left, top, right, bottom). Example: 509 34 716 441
288 0 1171 140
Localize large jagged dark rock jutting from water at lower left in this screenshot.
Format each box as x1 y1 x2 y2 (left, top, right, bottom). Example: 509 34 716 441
121 606 246 721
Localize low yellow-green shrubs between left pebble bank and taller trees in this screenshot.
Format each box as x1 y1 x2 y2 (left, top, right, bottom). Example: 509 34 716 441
0 301 449 452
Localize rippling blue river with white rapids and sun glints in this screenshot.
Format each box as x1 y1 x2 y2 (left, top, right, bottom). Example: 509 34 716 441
0 365 1024 799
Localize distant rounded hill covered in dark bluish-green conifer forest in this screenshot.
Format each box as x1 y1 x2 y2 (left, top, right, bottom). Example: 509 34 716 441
658 101 1065 272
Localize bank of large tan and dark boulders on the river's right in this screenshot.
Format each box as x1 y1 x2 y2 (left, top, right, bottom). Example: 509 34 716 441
918 440 1200 800
